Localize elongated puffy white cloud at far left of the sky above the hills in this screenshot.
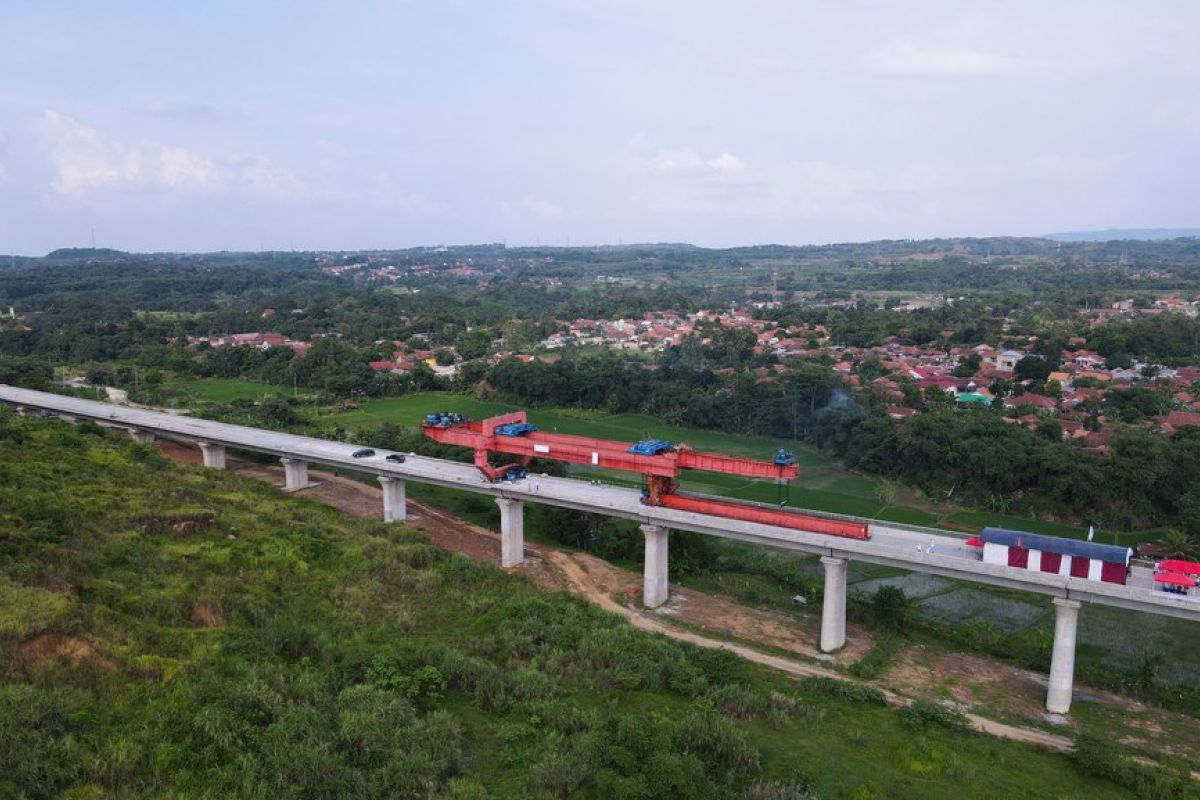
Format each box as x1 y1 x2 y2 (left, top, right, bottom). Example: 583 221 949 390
37 110 304 197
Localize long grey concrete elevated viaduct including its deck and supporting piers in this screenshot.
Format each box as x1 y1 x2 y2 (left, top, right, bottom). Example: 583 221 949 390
0 385 1200 714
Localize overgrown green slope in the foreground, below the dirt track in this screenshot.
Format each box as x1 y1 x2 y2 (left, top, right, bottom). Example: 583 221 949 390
0 414 1152 799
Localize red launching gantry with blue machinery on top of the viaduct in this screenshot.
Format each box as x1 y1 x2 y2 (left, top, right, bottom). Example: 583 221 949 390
421 411 870 539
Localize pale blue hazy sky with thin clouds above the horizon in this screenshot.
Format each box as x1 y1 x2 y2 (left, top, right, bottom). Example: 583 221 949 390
0 0 1200 255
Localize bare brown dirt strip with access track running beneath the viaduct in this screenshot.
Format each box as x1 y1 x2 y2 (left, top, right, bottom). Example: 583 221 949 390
160 441 1194 751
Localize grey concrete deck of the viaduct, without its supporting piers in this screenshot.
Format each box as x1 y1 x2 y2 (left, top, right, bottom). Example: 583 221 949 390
0 385 1200 620
